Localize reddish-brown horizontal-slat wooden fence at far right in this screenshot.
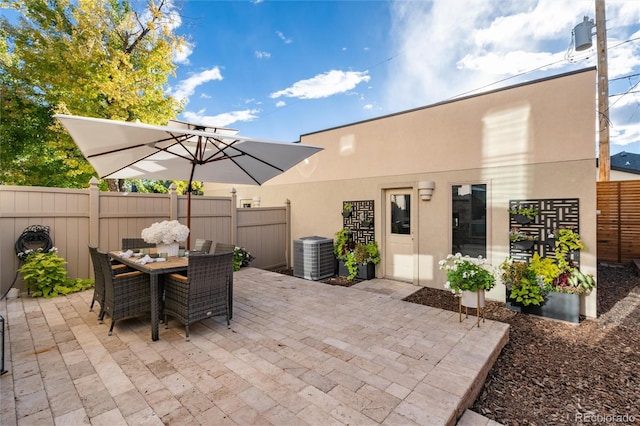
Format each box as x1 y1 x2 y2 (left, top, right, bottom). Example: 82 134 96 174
596 180 640 264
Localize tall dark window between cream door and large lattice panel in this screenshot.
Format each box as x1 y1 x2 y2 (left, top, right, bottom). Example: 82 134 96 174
451 184 487 257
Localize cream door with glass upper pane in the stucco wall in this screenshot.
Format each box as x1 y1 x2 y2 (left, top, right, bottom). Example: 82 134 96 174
383 188 417 282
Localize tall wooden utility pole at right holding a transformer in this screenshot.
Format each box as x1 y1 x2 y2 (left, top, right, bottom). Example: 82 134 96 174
596 0 611 182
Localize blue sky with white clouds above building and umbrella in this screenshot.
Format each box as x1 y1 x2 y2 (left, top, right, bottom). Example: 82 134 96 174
162 0 640 154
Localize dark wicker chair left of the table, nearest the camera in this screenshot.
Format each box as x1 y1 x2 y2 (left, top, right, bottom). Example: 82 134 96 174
95 250 151 336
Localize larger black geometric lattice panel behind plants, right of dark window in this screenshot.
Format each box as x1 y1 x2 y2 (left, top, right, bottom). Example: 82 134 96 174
509 198 580 266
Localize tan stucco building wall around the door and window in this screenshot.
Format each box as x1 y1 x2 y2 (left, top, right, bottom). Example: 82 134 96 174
205 68 596 317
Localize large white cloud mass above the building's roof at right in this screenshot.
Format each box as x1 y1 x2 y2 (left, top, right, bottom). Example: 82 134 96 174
385 0 640 110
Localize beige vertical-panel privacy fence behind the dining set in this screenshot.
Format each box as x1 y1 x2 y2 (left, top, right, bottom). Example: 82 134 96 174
0 180 291 296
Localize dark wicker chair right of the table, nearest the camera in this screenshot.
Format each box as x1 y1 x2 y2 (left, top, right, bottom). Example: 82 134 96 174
164 253 233 341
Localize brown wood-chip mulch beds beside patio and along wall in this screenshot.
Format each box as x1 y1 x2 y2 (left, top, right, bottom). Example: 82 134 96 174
278 265 640 425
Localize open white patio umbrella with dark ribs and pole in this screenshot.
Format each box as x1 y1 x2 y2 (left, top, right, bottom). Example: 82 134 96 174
54 114 322 248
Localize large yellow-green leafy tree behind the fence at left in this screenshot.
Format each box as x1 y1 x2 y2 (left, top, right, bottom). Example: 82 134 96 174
0 0 186 190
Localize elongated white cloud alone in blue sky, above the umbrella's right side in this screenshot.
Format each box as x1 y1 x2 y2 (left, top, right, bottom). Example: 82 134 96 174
269 70 371 99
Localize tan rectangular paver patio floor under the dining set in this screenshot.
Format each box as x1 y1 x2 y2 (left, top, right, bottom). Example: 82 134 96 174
0 268 508 426
